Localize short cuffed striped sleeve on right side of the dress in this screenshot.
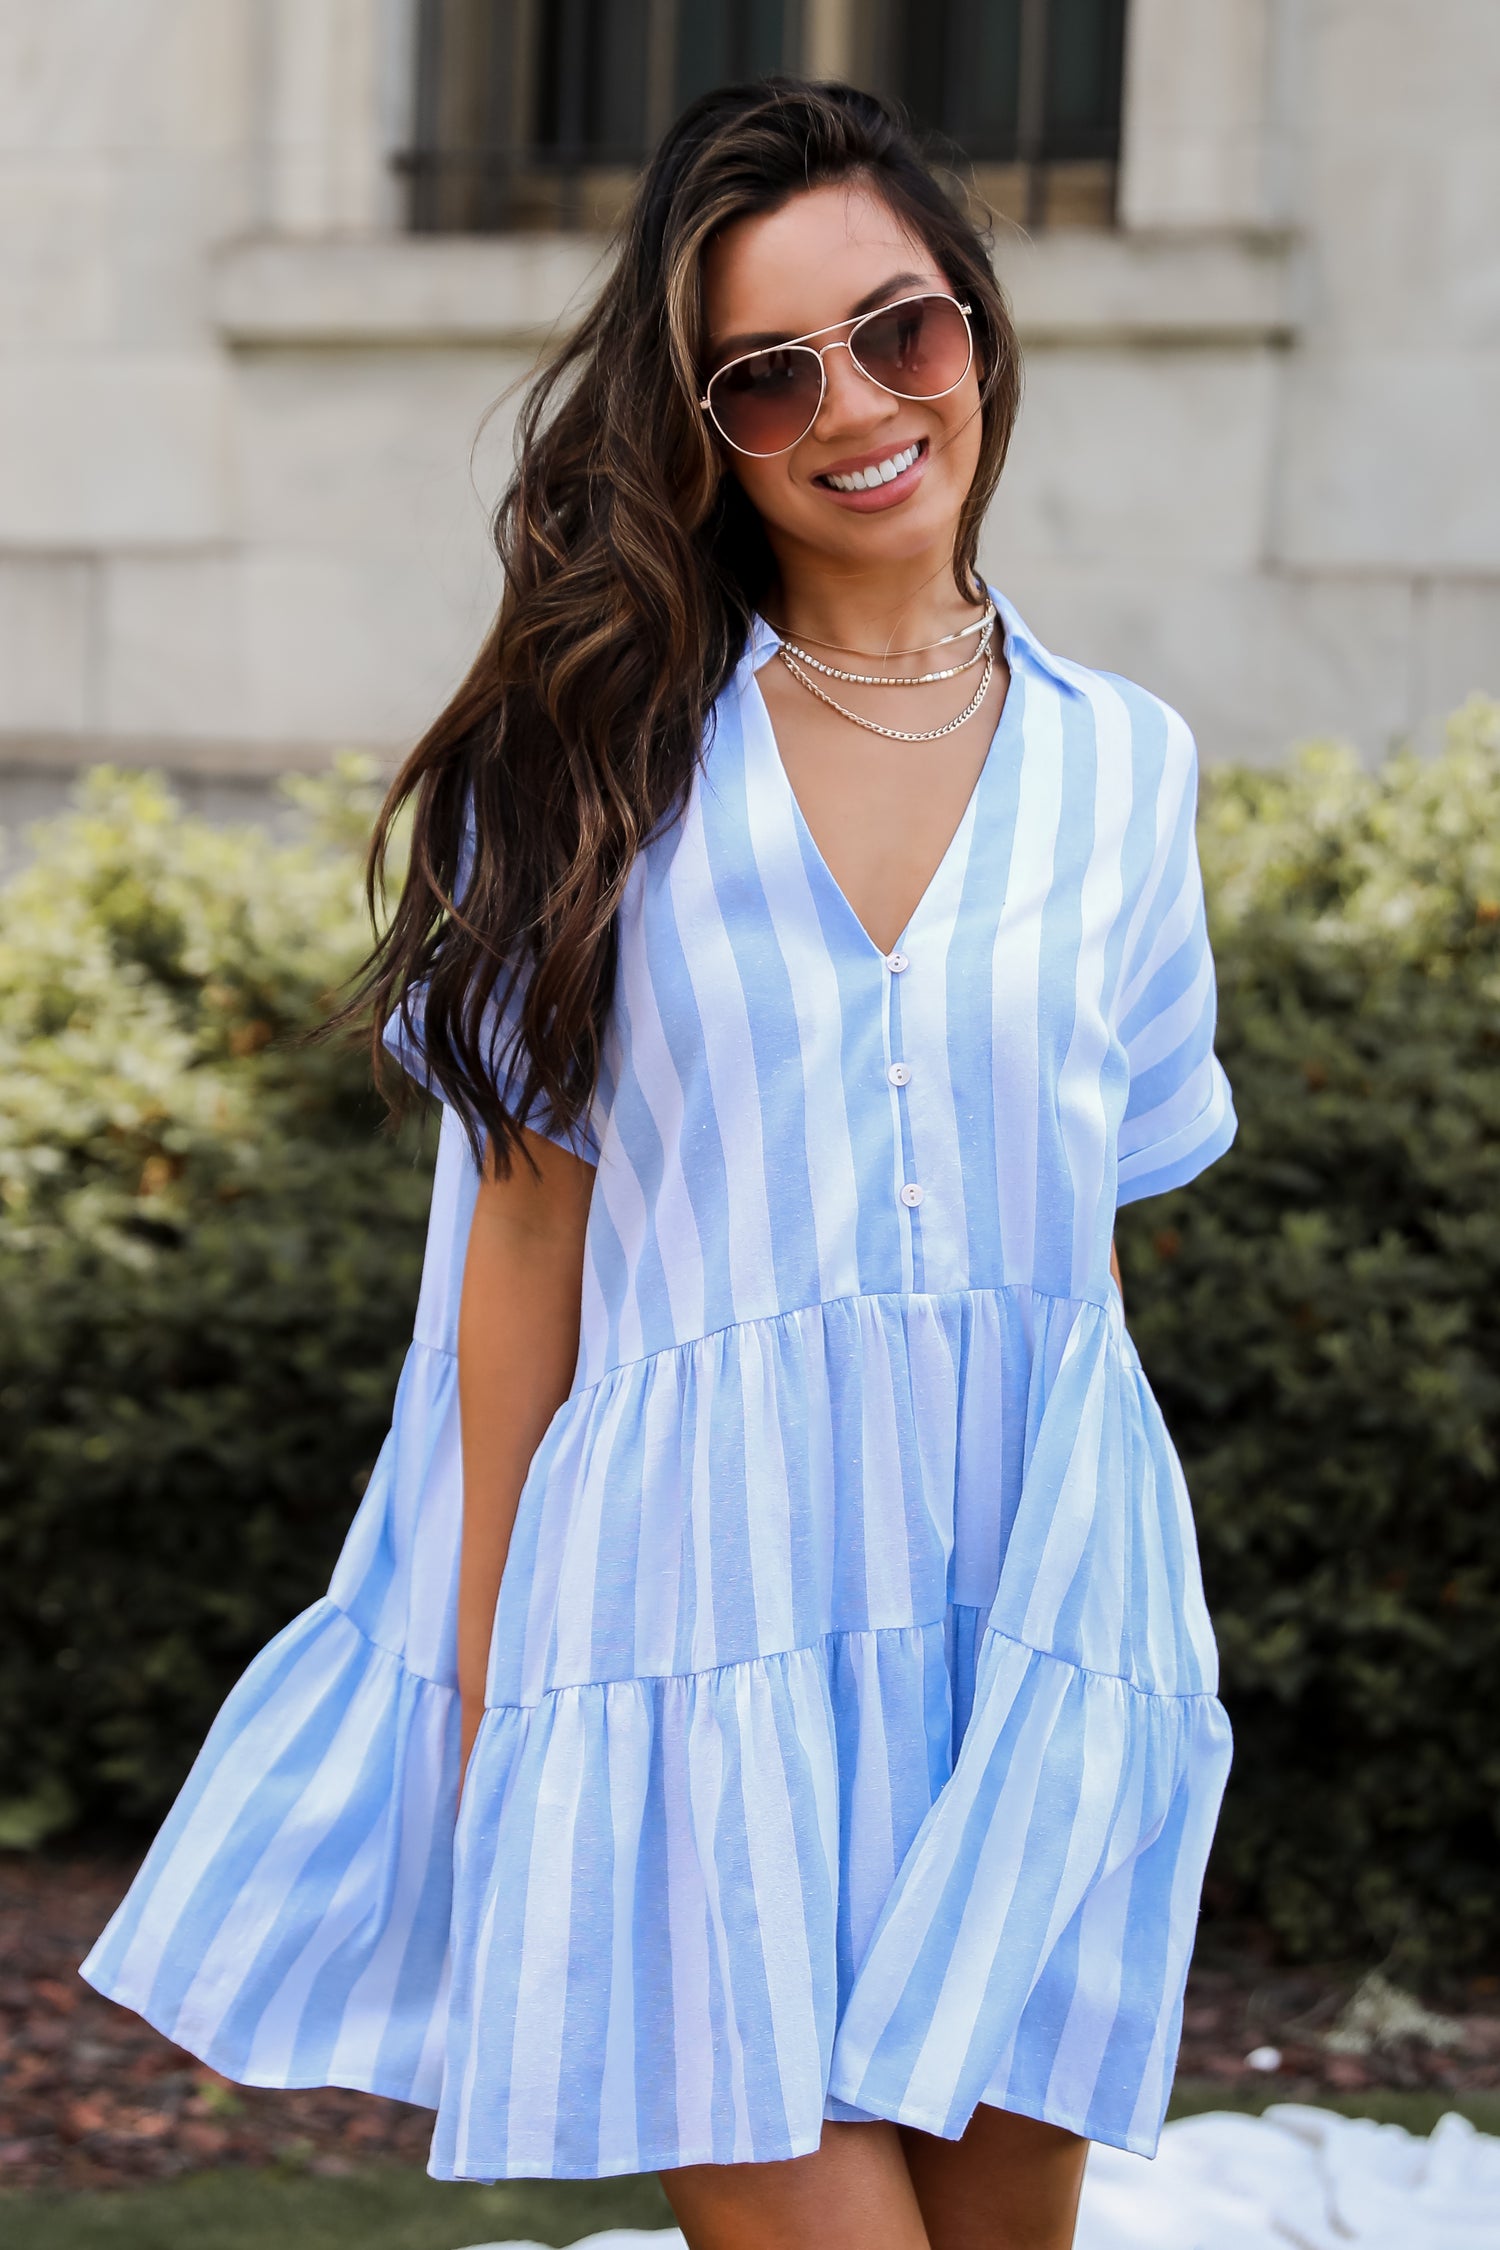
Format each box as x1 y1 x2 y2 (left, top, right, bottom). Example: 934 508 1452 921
1115 711 1237 1204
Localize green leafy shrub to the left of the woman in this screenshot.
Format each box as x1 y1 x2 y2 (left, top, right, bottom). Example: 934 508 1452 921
0 765 427 1843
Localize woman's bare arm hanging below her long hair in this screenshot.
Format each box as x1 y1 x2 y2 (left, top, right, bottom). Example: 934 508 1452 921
459 1132 594 1769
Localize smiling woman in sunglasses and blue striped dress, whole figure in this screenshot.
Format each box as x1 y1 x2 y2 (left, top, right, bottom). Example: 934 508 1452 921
88 81 1235 2250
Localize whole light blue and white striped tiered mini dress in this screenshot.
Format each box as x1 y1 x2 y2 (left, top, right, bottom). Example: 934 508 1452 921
85 603 1235 2180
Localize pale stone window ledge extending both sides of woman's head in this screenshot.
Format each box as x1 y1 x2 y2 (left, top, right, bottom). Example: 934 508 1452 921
214 230 1298 351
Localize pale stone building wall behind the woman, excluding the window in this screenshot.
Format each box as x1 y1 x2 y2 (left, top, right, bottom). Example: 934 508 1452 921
0 0 1500 837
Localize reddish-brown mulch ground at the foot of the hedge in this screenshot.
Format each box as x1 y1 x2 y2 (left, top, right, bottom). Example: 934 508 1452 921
0 1856 1500 2189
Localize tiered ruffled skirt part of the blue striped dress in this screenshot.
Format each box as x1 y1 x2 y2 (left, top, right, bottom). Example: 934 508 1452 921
85 1134 1228 2178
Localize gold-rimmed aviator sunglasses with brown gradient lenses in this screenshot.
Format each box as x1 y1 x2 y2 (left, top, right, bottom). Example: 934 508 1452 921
697 295 974 459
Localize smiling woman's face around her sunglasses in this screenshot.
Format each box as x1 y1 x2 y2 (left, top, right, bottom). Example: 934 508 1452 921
704 180 981 567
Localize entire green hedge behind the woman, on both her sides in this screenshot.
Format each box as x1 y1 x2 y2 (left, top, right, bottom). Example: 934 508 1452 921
0 702 1500 1971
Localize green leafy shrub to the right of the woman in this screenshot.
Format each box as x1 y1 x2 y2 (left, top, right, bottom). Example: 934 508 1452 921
1120 702 1500 1962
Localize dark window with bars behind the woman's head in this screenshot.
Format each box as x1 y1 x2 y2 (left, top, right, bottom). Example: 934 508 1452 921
398 0 1124 232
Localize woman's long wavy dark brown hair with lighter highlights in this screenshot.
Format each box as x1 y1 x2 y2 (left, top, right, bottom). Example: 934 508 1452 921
350 79 1019 1172
